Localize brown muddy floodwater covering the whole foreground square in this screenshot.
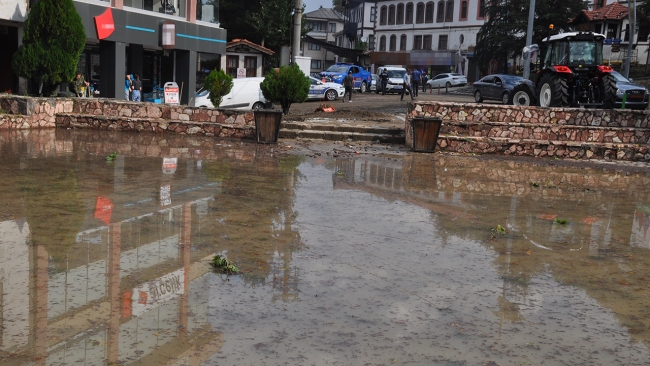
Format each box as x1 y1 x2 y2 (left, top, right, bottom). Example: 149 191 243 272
0 130 650 365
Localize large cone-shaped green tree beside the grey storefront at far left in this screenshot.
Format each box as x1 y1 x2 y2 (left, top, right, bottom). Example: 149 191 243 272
12 0 86 95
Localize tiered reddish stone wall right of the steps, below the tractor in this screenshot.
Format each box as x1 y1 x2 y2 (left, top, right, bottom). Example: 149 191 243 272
404 102 650 161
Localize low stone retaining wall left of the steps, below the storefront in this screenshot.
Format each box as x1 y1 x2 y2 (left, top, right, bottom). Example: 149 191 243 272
0 95 255 138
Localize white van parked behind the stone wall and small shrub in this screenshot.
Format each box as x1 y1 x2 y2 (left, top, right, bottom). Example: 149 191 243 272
194 77 273 111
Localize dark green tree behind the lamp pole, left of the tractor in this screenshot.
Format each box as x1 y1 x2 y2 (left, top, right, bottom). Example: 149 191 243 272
474 0 586 75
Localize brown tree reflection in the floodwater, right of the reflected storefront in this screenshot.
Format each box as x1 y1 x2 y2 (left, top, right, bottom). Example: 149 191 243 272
204 153 303 300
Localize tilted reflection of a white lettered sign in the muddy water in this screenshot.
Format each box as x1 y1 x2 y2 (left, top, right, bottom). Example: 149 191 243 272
131 268 185 316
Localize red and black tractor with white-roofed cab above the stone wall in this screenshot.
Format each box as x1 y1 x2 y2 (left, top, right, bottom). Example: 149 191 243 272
512 32 616 108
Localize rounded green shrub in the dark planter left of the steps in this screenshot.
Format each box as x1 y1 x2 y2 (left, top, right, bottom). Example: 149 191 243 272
260 64 311 114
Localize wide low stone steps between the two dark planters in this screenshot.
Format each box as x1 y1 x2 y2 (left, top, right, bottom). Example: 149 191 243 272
280 121 405 144
